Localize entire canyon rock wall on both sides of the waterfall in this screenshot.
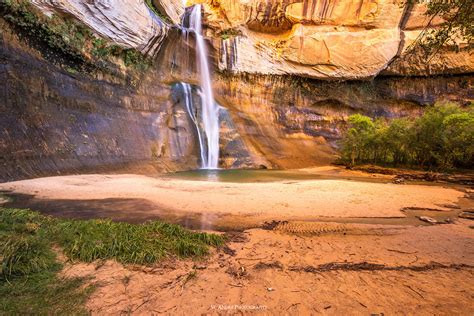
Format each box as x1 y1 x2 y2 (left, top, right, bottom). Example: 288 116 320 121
0 0 474 181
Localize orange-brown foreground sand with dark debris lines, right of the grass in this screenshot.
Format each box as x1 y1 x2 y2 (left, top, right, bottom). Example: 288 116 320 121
65 220 474 315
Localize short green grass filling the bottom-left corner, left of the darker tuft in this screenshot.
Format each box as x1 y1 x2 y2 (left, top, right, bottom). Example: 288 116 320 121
0 208 93 315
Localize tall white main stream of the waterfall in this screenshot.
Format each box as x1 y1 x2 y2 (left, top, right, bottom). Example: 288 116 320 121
187 4 219 169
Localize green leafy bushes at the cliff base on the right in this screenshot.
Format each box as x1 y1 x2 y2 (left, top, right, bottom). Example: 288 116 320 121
341 103 474 170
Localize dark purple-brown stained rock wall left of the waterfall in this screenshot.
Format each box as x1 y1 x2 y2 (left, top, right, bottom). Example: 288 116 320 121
0 20 199 181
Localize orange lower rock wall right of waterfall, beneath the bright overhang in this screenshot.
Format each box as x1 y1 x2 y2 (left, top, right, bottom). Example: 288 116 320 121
215 75 474 168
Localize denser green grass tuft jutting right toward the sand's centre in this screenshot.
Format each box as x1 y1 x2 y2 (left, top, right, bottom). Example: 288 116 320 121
50 220 223 264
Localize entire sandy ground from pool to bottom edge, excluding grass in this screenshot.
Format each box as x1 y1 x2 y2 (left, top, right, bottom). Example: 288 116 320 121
0 169 474 315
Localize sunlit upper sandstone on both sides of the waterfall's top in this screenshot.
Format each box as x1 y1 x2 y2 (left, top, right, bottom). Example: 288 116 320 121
25 0 474 80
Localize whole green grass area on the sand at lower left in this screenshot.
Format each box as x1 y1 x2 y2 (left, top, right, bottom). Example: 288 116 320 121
0 208 223 314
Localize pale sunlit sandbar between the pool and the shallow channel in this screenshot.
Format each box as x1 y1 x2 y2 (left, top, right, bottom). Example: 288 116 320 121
0 174 465 221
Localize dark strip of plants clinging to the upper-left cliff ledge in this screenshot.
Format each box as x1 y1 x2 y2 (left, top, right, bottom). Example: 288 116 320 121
0 0 151 71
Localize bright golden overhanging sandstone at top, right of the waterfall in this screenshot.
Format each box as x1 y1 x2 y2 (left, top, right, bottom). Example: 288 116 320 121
206 0 474 80
